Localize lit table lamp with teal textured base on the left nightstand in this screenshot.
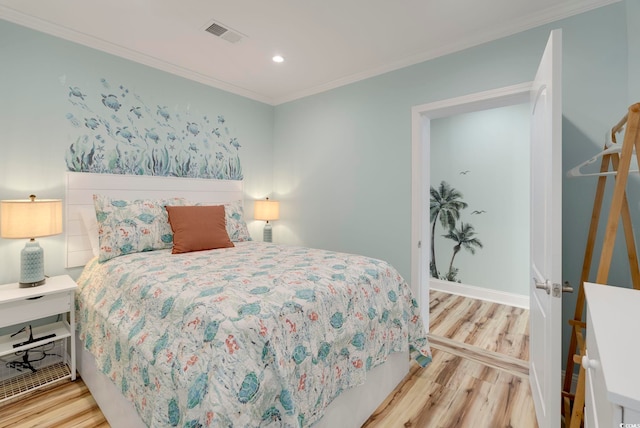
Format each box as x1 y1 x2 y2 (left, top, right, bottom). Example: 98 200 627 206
0 195 62 288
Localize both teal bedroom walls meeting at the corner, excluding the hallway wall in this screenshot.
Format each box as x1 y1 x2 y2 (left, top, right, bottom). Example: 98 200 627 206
0 0 640 374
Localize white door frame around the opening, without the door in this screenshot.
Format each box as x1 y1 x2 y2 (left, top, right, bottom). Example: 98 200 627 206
411 82 533 331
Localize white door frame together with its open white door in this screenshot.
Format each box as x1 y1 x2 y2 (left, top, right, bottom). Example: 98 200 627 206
411 29 562 428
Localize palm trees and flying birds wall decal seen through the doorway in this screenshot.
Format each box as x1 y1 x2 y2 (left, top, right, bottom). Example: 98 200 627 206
429 177 485 282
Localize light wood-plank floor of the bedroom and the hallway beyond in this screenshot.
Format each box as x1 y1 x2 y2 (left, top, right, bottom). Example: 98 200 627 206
0 291 537 428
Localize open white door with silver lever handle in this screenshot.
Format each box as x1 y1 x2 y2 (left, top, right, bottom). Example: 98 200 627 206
529 30 562 428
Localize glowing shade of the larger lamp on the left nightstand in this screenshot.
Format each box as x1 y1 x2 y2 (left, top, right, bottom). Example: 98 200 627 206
0 198 62 239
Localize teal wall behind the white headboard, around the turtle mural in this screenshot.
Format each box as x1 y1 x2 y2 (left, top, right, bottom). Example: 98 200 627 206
0 20 274 283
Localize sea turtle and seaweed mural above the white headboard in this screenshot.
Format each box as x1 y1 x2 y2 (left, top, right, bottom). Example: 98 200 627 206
65 78 243 180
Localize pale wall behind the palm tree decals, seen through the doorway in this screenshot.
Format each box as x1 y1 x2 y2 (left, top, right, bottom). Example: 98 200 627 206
428 104 531 296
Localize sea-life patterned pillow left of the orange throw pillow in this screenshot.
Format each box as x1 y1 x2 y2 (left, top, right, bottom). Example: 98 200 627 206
93 195 185 262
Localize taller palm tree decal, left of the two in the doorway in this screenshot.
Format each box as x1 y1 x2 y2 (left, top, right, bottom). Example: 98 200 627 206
429 181 467 278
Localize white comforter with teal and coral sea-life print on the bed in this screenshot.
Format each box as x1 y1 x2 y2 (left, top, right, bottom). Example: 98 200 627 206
76 242 431 428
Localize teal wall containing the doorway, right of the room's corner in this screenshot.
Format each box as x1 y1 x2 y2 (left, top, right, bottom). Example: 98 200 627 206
274 1 640 374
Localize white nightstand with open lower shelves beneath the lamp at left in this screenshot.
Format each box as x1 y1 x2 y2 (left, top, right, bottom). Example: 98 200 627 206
0 275 77 403
